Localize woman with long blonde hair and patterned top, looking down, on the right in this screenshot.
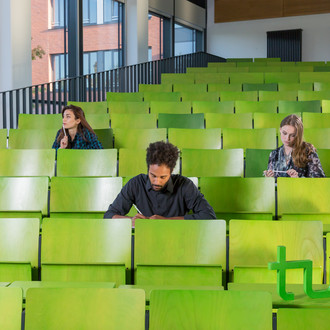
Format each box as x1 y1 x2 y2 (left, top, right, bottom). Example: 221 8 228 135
264 115 325 178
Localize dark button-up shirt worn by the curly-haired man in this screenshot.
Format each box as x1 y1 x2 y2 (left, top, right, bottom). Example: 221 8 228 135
104 174 216 219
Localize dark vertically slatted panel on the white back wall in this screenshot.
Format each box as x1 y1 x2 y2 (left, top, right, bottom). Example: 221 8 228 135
267 29 302 62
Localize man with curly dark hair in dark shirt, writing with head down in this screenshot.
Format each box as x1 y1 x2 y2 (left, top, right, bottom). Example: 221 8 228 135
104 141 216 225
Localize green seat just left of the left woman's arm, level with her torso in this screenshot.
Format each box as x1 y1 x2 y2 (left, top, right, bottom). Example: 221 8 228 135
8 129 57 149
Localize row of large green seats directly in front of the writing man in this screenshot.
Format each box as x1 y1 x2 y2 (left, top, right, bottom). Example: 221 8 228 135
0 218 324 284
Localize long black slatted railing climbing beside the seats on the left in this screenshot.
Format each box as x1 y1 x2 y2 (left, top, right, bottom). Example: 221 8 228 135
0 52 225 128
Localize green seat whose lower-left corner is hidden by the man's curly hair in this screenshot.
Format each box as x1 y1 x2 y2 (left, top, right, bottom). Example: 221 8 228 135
168 128 221 150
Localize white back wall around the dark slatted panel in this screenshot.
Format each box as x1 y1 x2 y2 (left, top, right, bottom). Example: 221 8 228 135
207 0 330 61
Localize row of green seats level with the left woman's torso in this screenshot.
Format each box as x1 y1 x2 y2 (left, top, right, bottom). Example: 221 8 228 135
3 127 330 149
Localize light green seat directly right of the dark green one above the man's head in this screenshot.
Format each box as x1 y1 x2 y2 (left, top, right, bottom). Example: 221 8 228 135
205 113 252 128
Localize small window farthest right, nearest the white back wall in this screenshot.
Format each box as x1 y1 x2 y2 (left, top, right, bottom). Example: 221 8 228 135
174 24 196 56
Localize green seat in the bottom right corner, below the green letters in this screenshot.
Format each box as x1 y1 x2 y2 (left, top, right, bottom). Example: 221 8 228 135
276 308 330 330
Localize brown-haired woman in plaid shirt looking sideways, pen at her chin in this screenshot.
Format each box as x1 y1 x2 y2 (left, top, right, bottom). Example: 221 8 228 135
53 105 103 149
